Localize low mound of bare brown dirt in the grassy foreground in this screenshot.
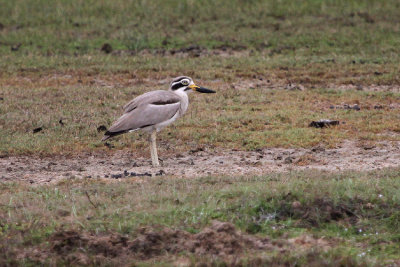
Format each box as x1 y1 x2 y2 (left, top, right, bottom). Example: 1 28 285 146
24 221 324 265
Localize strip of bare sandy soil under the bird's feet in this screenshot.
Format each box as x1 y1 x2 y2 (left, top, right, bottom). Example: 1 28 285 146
0 141 400 184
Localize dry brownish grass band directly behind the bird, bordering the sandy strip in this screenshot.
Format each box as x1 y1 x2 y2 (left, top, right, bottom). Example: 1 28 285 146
0 75 400 155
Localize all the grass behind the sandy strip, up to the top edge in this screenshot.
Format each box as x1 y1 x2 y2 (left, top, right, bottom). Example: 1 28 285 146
0 0 400 155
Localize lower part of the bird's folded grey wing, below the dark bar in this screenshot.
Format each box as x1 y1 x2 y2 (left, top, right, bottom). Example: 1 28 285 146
103 102 180 140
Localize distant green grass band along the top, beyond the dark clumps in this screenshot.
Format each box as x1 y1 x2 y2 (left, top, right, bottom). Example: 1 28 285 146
0 0 400 56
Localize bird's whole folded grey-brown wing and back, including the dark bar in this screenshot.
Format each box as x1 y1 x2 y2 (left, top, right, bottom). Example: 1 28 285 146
103 91 181 140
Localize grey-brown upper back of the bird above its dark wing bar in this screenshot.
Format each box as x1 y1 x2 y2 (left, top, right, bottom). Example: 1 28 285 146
123 90 181 113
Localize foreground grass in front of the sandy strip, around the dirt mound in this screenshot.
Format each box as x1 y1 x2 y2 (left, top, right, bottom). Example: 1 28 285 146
0 169 400 266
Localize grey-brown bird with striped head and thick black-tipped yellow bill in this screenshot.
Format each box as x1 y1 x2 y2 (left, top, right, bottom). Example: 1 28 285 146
102 76 216 167
